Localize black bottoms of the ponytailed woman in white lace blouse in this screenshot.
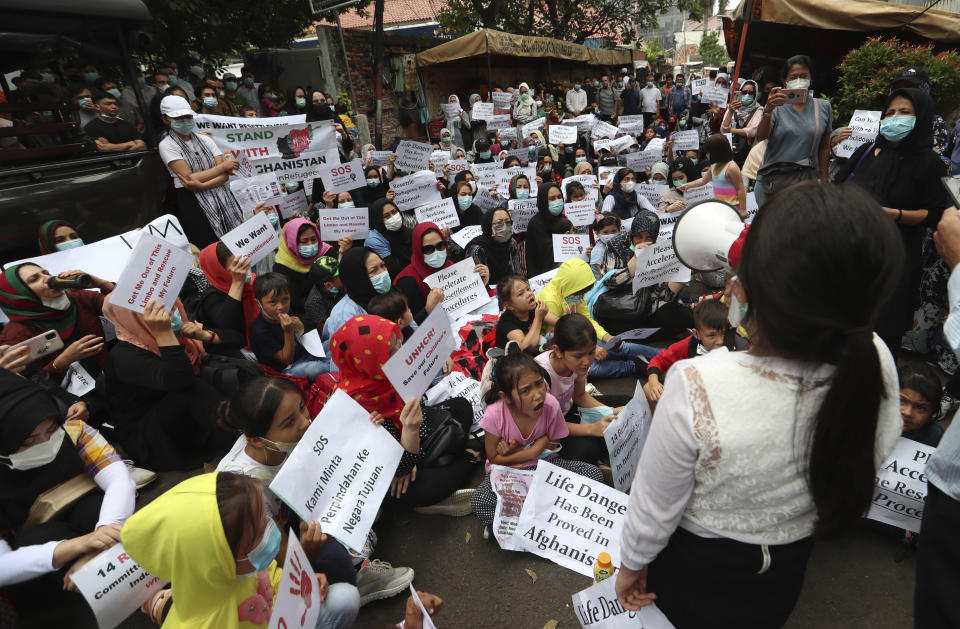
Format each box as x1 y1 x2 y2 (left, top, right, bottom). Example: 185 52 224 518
647 528 813 629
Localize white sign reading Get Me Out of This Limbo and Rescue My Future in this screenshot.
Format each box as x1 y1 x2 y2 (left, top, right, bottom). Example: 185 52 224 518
109 233 193 313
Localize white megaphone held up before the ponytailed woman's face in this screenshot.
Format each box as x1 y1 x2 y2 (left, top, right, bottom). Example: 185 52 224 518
673 200 743 273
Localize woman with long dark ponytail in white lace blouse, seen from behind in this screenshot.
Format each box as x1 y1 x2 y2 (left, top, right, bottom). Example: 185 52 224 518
617 182 904 629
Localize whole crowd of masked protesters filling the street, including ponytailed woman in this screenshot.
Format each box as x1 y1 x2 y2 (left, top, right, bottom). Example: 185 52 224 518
0 50 960 629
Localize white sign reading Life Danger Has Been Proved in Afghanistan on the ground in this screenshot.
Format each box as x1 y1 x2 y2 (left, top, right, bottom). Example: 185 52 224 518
515 460 629 576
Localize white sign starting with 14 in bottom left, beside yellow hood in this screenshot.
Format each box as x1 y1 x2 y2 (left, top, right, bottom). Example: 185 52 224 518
70 544 168 629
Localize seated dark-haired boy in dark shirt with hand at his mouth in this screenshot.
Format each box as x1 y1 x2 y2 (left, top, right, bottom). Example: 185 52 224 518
248 273 330 382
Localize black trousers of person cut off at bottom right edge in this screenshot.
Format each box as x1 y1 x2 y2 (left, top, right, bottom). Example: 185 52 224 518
913 483 960 629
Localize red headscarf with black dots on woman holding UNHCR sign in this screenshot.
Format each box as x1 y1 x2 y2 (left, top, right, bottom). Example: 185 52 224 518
330 315 403 430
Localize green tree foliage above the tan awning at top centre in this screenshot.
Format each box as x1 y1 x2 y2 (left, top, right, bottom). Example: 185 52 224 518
437 0 672 43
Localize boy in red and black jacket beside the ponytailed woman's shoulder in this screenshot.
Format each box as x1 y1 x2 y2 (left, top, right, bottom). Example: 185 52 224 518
643 299 736 404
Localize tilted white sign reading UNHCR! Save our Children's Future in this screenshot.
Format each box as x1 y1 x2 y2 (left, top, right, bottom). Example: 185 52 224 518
383 306 458 400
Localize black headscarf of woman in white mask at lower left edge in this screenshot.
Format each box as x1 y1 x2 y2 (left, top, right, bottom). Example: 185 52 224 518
0 369 84 530
